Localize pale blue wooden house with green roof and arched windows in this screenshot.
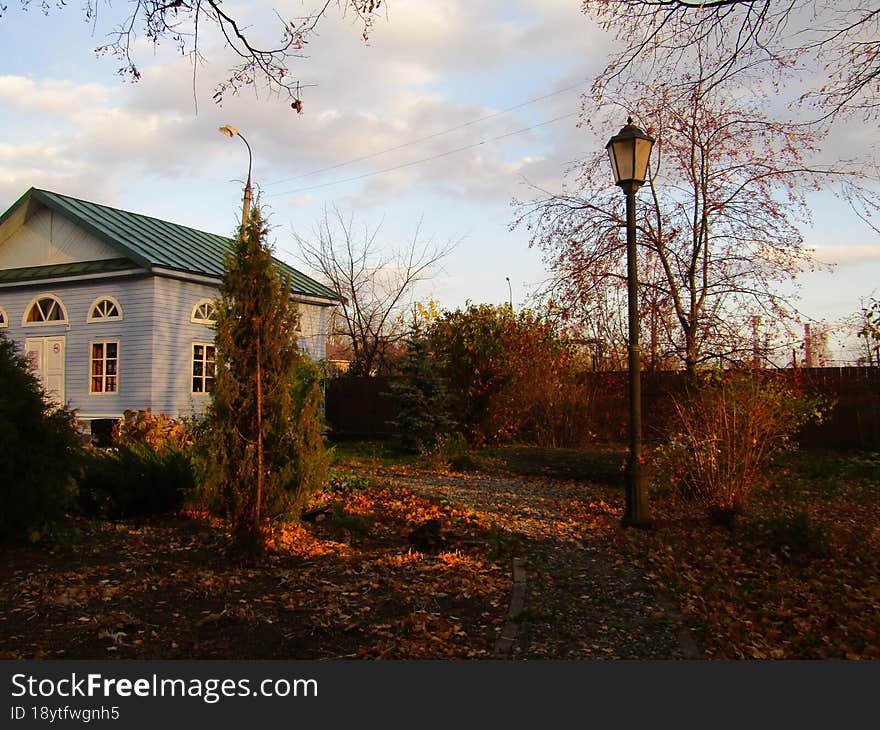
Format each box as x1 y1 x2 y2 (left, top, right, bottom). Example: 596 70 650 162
0 188 339 436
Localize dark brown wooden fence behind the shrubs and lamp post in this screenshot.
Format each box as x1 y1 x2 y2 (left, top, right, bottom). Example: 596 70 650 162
326 367 880 451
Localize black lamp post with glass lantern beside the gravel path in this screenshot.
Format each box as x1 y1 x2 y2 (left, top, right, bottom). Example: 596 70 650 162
605 118 654 527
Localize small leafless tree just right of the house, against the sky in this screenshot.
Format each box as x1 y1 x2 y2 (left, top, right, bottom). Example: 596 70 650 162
294 207 456 375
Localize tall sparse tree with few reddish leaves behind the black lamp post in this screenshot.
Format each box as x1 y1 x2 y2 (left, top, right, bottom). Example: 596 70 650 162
517 64 843 372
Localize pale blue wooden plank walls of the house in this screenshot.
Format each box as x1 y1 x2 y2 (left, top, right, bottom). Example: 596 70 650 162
0 276 329 420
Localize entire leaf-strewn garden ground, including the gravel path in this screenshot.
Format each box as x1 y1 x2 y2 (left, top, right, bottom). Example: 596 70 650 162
0 449 880 659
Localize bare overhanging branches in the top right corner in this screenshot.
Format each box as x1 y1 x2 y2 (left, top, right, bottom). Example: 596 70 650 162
583 0 880 117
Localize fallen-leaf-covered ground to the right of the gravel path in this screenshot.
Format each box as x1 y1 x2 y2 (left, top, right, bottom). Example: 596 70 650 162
621 452 880 659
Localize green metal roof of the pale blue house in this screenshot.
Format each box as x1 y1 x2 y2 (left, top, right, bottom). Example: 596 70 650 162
0 188 339 301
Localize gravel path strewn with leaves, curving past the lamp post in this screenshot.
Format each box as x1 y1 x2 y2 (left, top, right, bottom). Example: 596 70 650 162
392 474 702 659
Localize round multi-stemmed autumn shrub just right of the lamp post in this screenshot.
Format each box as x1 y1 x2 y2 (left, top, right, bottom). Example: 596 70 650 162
654 370 830 521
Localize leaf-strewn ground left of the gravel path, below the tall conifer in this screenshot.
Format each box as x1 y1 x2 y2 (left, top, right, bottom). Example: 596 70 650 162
0 480 509 659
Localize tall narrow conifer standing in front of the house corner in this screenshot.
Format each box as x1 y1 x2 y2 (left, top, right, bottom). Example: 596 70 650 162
209 209 324 556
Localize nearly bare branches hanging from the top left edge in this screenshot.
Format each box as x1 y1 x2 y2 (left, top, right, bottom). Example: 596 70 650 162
0 0 382 104
